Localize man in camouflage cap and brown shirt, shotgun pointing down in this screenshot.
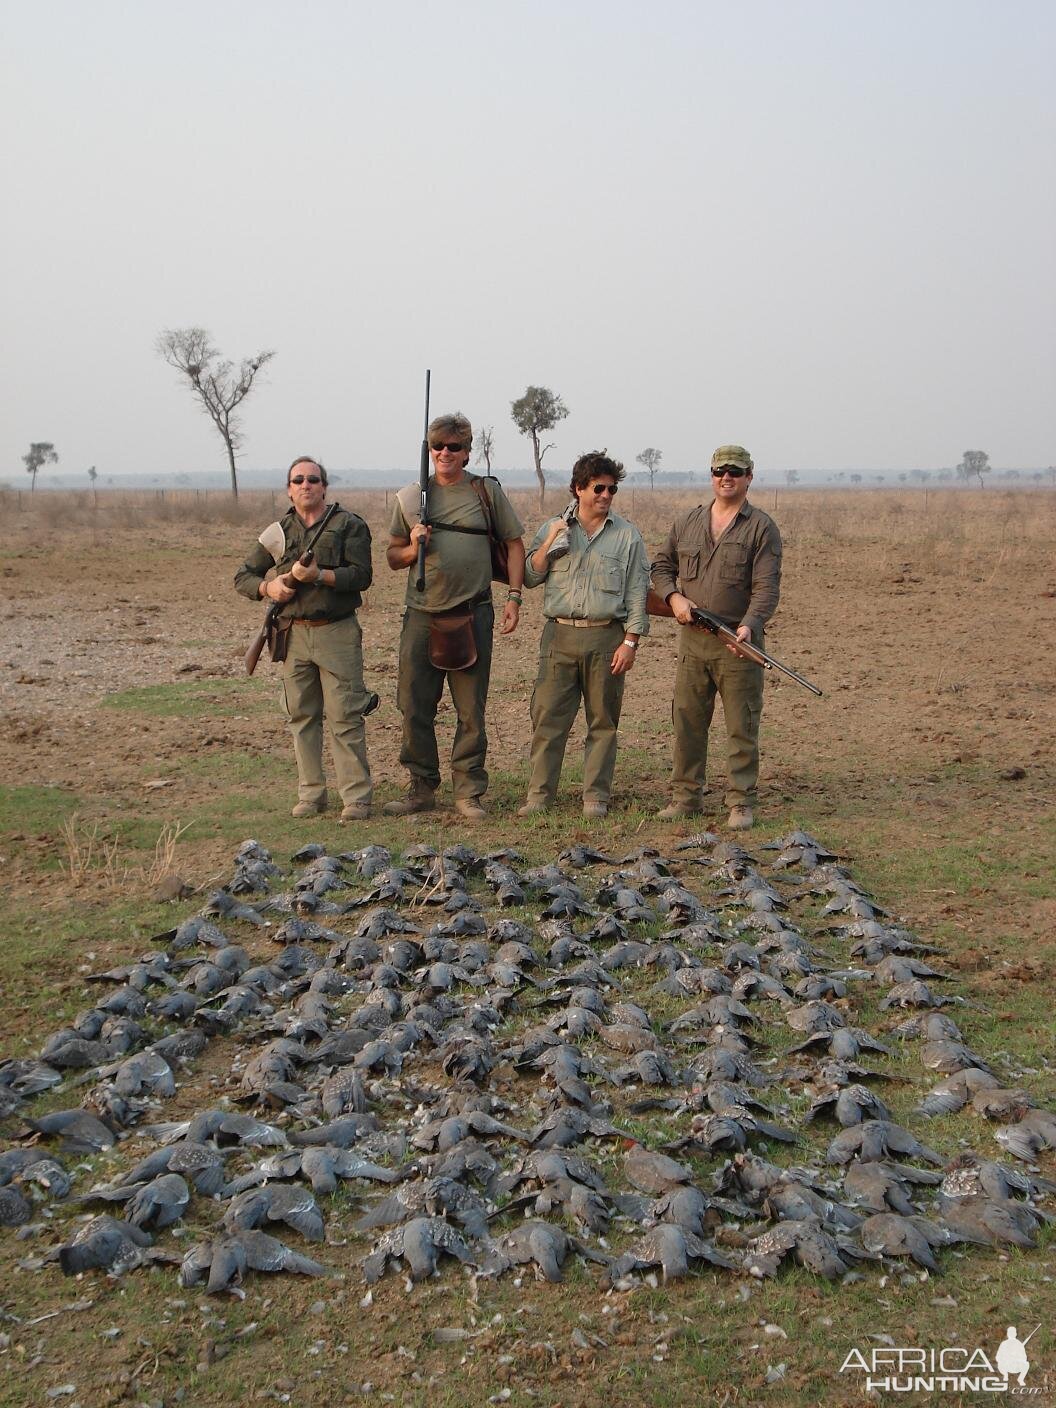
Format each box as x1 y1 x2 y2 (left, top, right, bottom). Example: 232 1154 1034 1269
652 445 781 831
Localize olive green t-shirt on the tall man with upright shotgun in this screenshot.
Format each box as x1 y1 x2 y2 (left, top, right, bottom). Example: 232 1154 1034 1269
389 474 524 611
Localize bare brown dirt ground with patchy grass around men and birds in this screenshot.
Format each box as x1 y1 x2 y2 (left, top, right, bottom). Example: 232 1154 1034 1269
0 486 1056 1404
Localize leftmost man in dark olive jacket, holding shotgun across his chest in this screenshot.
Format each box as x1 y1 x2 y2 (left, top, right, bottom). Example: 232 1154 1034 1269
235 456 377 821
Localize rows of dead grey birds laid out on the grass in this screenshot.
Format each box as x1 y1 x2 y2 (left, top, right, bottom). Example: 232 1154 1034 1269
0 832 1056 1294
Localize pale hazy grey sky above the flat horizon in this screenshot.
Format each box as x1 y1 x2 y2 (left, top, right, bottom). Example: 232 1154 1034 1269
0 0 1056 483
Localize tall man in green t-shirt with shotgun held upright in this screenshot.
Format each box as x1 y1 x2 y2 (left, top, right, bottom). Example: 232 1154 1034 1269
384 413 524 819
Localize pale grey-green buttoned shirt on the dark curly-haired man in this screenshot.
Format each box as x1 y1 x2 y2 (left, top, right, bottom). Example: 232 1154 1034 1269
524 514 649 635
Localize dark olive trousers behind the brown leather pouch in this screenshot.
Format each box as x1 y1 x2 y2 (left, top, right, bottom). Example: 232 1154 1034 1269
396 601 496 801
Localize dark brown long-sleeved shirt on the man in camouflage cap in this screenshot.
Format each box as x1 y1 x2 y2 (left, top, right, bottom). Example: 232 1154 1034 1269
652 500 781 639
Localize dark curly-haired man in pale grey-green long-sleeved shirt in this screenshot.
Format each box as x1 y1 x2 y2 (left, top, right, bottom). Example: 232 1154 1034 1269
518 451 649 817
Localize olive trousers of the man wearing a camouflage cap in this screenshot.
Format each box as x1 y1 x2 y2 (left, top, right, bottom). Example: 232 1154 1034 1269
672 627 763 807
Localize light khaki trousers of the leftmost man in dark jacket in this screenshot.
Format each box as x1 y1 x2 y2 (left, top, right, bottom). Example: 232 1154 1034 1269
283 615 372 807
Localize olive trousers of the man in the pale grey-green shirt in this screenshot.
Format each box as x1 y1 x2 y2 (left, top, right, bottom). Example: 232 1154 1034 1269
528 621 624 807
